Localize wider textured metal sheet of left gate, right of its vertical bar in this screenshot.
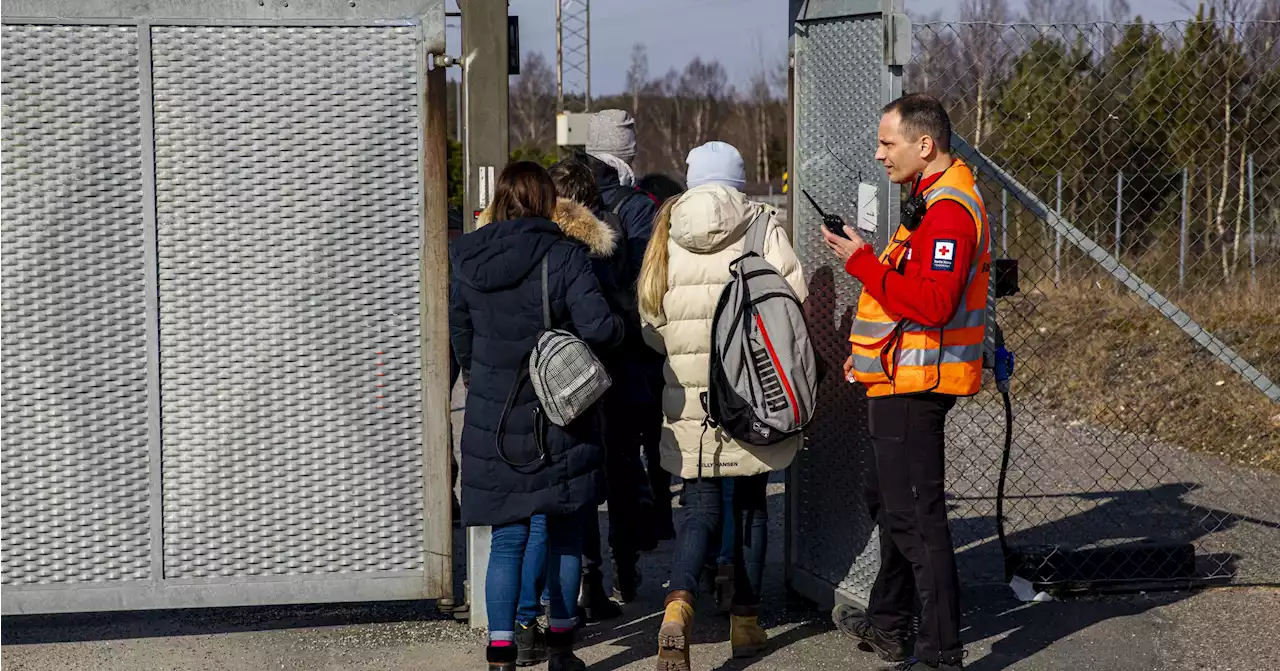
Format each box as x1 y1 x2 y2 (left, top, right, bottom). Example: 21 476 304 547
152 27 422 579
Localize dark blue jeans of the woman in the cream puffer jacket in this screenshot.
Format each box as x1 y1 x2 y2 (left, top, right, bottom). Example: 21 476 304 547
669 473 769 606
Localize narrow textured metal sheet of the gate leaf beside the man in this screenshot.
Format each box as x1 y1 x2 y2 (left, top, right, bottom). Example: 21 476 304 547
791 14 888 602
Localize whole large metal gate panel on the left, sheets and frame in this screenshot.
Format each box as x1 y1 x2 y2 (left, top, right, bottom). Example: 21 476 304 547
0 0 452 615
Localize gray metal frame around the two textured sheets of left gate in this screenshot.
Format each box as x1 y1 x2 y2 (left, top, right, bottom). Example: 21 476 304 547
0 0 453 616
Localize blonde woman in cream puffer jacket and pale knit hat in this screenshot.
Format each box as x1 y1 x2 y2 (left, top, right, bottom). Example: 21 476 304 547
637 142 808 671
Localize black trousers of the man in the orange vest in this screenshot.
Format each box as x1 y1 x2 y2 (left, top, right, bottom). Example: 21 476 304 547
867 394 964 665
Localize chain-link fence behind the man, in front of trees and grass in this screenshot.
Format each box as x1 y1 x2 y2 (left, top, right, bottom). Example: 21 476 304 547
904 15 1280 585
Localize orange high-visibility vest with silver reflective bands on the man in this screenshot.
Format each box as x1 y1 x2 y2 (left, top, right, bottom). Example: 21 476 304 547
849 159 991 397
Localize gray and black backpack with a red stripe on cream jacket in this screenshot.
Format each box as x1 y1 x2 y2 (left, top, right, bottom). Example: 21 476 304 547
701 210 818 446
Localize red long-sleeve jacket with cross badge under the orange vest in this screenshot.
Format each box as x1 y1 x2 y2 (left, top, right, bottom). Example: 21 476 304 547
845 173 978 328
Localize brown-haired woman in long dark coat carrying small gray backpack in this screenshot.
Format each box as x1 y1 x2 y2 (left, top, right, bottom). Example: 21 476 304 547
449 161 625 671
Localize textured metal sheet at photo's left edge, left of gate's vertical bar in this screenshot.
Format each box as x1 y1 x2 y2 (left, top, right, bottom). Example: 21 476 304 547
0 26 151 586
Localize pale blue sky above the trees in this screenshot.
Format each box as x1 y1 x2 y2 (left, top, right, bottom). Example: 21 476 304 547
448 0 1187 93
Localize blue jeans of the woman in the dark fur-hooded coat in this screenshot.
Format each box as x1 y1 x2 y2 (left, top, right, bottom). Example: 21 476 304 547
485 510 594 640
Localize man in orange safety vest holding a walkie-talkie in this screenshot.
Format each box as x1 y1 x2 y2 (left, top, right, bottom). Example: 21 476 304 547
823 93 991 671
